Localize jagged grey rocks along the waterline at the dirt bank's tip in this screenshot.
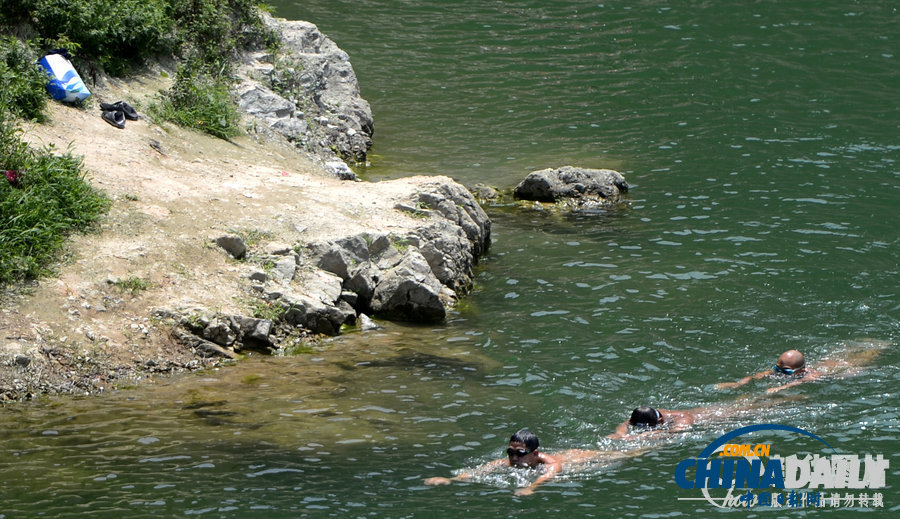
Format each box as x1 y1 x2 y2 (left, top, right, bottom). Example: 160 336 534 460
171 178 491 357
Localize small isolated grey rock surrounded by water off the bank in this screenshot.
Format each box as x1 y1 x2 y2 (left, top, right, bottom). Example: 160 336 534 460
513 166 628 209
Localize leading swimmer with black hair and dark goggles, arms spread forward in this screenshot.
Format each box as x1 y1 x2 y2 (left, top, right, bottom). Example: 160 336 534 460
425 429 639 496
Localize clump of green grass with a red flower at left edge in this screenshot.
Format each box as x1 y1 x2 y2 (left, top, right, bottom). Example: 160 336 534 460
0 104 110 284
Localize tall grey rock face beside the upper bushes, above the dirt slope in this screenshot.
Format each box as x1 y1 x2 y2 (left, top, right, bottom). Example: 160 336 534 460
237 16 374 172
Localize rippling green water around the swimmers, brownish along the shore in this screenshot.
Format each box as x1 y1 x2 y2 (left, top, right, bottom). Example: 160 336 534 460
0 0 900 518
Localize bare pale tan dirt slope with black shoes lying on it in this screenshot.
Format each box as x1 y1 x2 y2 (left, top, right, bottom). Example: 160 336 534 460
0 72 448 399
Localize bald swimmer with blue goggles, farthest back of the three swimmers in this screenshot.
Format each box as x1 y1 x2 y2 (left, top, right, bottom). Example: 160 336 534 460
716 347 884 393
